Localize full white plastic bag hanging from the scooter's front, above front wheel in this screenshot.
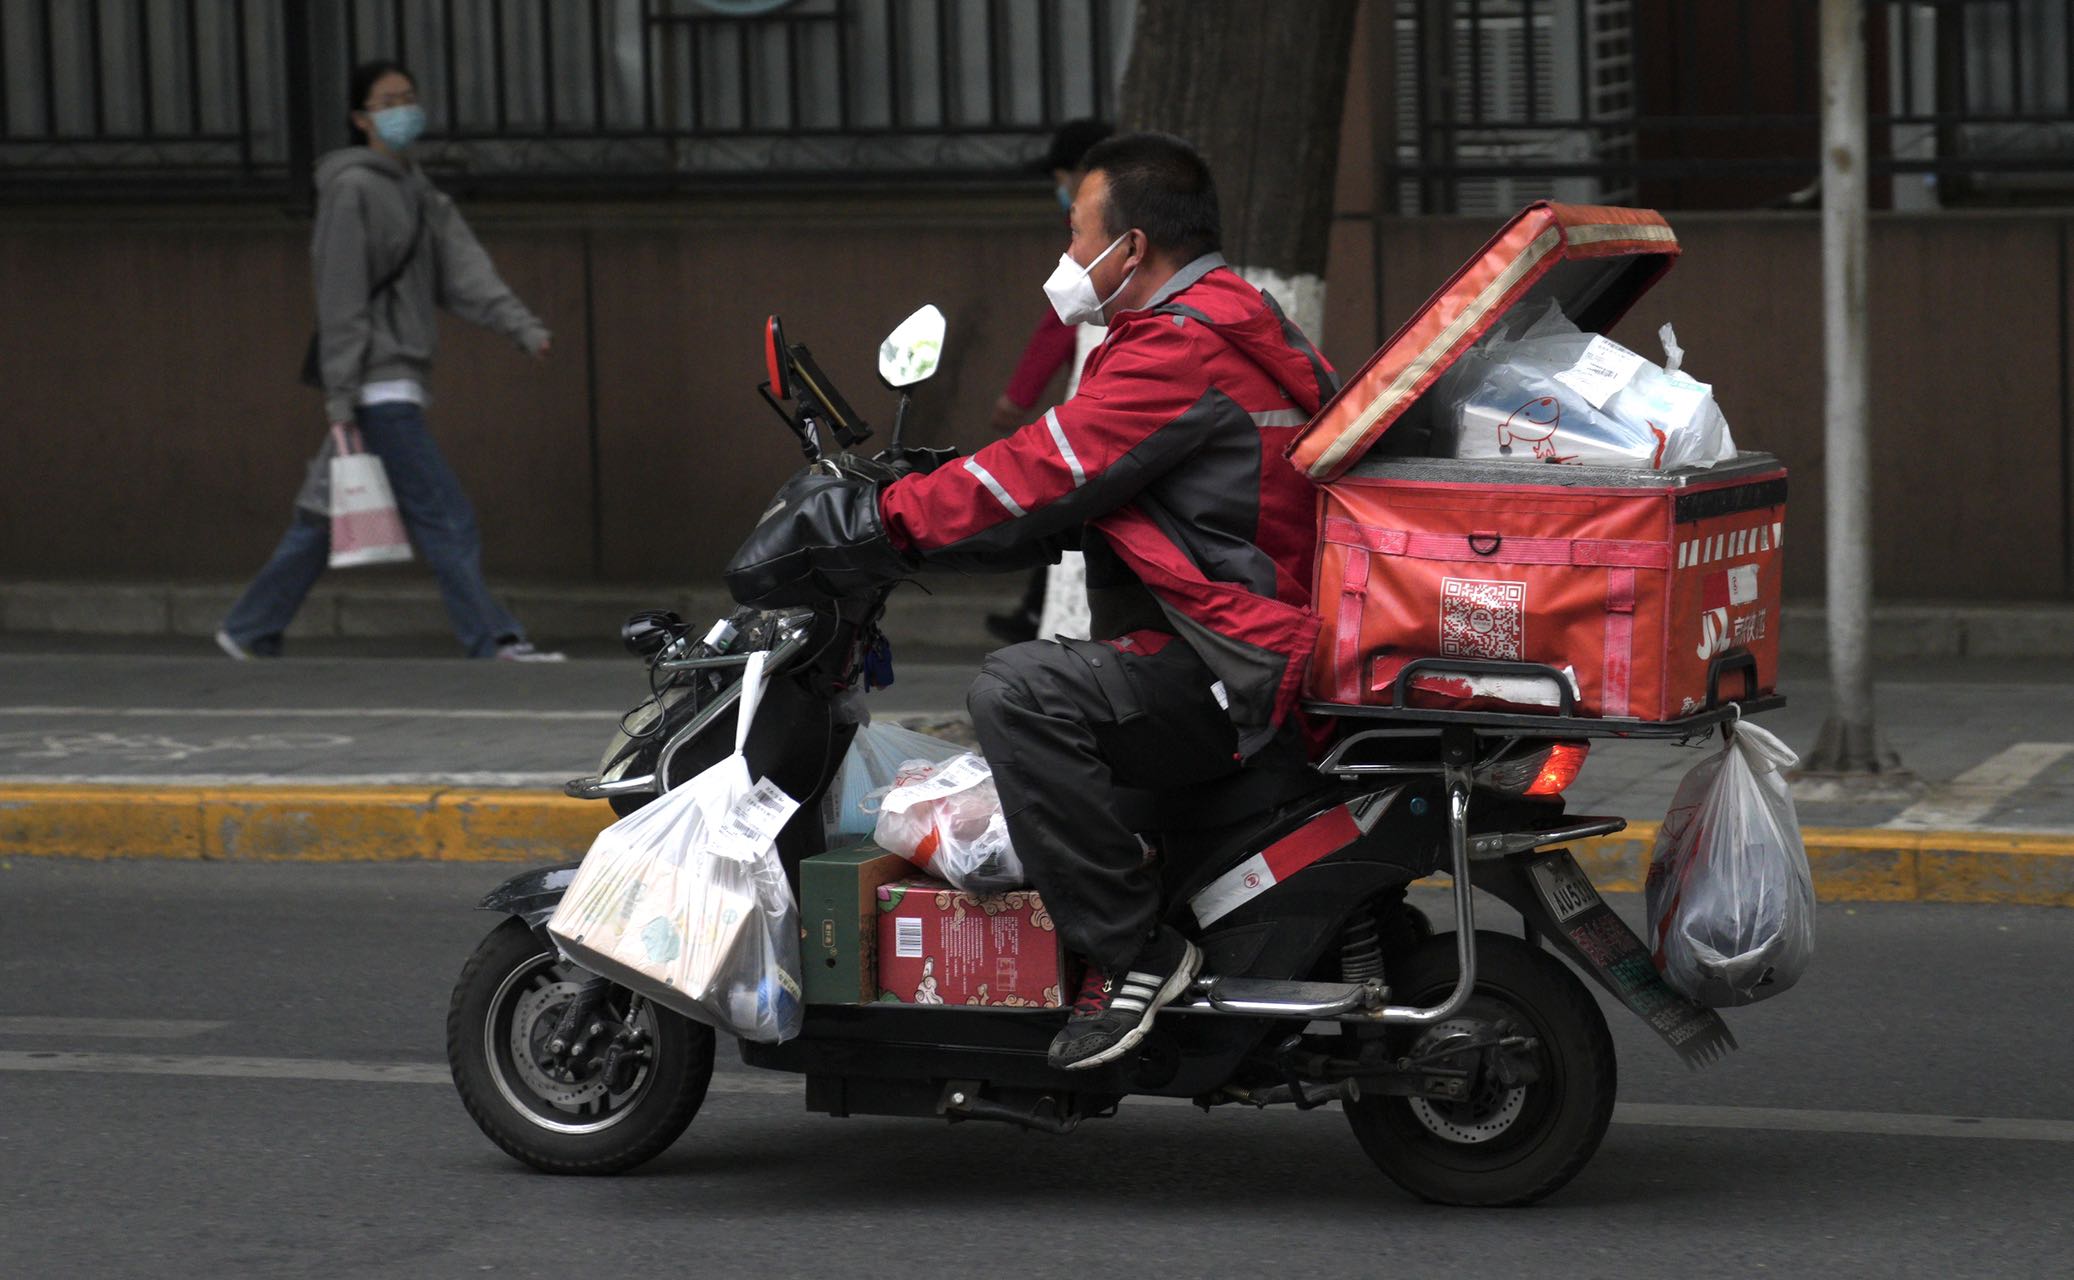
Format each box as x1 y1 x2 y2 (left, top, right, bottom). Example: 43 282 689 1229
548 653 801 1041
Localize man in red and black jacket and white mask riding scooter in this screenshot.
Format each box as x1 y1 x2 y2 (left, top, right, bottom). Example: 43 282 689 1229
728 133 1336 1068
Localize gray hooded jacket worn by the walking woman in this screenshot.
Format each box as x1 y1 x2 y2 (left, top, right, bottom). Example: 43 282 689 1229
311 147 548 421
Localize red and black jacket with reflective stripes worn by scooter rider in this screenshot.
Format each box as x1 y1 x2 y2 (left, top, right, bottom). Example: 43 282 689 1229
879 253 1338 753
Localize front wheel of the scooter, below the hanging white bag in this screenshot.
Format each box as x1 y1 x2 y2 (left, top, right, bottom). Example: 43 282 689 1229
446 919 713 1174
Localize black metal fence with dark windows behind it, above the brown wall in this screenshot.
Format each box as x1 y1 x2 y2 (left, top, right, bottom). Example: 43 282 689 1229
0 0 2074 204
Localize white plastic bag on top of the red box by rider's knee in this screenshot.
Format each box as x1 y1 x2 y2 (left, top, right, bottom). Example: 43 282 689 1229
873 751 1027 896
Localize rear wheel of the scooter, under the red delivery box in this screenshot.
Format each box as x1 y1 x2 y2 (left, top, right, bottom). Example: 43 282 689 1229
1346 931 1618 1205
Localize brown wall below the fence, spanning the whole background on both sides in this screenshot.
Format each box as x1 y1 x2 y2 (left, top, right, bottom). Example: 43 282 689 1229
0 195 2074 600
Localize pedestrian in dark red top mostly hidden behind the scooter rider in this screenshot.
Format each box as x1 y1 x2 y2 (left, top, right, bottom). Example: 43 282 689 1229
987 120 1114 643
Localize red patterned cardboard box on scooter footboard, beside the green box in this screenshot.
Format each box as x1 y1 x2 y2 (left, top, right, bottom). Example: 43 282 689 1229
877 880 1066 1008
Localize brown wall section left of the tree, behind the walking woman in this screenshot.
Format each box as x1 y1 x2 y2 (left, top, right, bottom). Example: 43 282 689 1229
0 195 1060 581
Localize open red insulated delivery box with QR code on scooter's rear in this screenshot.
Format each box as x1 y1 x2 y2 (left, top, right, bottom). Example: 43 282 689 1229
1290 203 1786 720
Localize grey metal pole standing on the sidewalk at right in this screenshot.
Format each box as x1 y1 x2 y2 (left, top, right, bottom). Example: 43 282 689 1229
1809 0 1881 774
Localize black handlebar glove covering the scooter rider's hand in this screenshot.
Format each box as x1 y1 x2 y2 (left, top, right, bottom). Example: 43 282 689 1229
726 456 915 608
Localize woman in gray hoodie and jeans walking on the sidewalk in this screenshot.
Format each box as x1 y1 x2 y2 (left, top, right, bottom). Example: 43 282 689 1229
216 62 562 662
